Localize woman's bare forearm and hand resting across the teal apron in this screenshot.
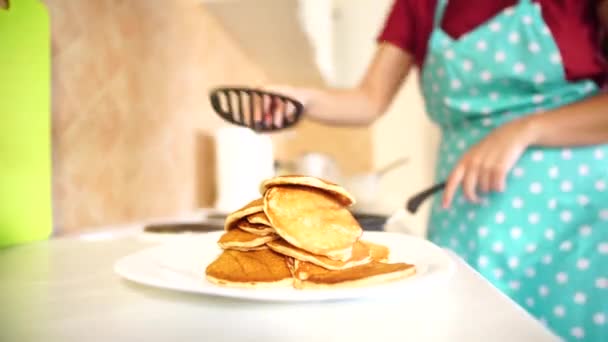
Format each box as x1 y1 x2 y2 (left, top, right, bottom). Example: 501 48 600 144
442 93 608 208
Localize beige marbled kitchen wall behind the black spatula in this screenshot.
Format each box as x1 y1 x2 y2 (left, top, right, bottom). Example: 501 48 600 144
45 0 372 233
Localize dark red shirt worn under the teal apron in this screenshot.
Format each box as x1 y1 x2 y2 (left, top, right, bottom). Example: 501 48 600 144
378 0 607 84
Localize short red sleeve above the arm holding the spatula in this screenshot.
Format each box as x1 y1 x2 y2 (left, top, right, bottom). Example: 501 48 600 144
377 0 416 54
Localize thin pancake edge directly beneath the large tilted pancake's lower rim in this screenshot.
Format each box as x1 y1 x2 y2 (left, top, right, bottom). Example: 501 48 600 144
266 239 372 270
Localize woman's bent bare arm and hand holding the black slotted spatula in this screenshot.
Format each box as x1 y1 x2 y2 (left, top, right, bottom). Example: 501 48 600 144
268 44 413 126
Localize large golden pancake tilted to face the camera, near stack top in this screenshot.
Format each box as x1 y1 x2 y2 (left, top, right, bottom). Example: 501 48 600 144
264 186 363 261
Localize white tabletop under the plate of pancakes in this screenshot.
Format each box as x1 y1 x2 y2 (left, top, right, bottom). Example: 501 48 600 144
0 226 558 342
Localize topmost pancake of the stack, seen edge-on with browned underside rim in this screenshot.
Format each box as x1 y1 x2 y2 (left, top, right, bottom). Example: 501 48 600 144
260 175 356 206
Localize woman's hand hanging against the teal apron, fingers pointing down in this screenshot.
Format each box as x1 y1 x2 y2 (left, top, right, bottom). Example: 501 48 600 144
442 118 535 208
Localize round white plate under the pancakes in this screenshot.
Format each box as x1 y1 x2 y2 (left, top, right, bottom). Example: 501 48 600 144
114 232 455 301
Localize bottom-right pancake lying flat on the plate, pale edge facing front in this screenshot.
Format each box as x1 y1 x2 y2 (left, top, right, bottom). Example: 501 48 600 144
294 260 416 289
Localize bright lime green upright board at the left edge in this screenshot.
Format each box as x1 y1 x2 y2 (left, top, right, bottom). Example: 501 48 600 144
0 0 52 247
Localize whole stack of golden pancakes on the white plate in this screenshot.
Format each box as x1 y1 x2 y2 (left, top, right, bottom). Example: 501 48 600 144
206 176 416 289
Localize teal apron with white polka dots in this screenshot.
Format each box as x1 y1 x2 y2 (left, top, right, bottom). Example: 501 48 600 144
422 0 608 341
